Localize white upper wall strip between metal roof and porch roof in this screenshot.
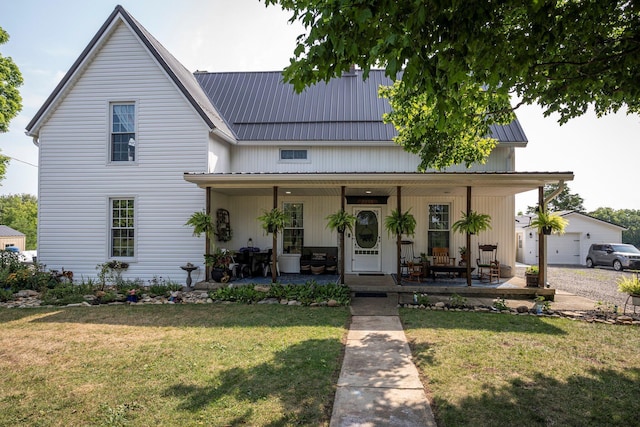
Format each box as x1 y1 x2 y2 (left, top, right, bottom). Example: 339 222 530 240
231 141 515 173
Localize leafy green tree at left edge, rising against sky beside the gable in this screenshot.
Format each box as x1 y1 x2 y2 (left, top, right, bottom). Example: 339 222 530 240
0 27 22 132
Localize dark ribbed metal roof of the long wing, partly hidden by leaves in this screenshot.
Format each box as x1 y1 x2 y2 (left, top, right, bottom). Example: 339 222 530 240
195 70 527 144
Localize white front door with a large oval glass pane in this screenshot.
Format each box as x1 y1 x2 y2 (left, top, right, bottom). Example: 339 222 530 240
351 206 382 272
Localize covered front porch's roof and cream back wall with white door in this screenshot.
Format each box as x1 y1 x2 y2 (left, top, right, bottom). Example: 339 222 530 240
184 172 573 287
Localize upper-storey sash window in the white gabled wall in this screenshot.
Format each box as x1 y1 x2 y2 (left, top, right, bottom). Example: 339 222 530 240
111 104 136 162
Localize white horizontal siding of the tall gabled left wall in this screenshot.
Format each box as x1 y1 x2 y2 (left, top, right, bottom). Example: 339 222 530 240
38 23 209 282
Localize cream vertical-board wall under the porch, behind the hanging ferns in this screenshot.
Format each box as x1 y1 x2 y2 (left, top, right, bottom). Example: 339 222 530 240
211 192 515 273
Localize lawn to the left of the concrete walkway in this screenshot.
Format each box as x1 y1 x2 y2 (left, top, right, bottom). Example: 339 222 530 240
0 304 349 426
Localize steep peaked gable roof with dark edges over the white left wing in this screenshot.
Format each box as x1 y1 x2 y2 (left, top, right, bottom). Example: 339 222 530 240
26 5 231 138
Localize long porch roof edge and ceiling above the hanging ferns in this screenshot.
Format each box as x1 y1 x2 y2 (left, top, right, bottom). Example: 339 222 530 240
184 172 574 197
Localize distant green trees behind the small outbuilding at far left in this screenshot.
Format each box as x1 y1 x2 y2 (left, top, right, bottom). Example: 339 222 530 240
0 194 38 250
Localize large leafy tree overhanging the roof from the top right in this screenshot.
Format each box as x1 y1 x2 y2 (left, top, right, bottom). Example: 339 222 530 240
265 0 640 169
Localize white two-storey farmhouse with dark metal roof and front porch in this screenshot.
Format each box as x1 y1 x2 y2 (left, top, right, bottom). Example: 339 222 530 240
27 6 573 281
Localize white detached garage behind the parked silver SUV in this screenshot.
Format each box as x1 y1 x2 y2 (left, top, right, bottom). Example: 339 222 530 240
516 211 626 265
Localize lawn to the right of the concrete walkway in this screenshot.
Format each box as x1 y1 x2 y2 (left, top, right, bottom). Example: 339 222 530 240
401 310 640 426
